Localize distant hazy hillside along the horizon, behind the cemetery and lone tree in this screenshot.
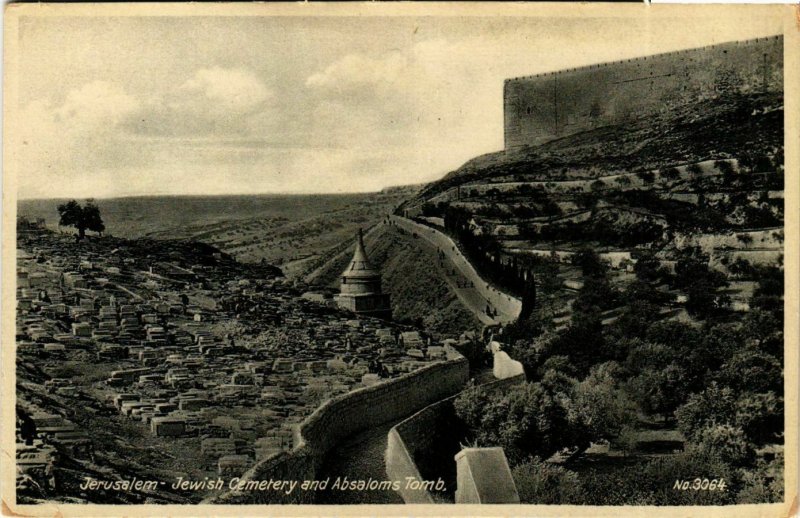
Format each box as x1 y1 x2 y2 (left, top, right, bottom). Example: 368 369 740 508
19 186 416 277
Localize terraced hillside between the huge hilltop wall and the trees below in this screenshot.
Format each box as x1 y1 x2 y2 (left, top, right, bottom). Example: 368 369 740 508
396 94 784 328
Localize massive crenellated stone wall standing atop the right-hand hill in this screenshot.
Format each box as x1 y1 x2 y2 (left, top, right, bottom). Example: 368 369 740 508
503 36 783 149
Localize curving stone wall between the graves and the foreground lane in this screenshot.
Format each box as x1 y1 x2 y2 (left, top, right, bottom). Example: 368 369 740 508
207 350 469 504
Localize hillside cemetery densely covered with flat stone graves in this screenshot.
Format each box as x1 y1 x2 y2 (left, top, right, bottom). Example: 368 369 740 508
16 225 445 502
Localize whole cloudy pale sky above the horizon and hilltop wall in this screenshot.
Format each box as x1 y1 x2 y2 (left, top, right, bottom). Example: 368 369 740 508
10 11 781 199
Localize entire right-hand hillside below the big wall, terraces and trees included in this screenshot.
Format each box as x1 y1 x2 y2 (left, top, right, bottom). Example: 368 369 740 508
396 94 784 505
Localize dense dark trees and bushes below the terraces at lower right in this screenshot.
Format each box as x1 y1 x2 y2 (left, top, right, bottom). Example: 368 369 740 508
455 248 783 505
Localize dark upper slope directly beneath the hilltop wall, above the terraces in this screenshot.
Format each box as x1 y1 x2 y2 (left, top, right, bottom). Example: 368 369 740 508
402 94 783 209
